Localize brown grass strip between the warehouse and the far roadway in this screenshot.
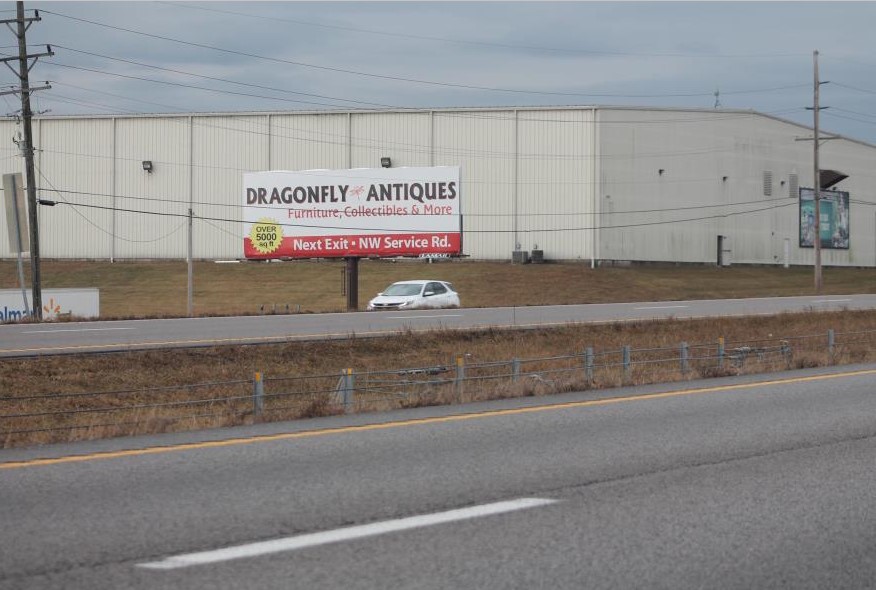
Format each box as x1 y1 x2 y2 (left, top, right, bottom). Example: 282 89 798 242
0 260 876 319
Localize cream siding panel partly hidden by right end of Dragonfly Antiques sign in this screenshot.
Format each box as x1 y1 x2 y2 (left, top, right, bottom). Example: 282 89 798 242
434 111 514 260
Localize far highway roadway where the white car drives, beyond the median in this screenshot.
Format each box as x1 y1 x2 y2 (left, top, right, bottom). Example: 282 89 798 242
0 294 876 358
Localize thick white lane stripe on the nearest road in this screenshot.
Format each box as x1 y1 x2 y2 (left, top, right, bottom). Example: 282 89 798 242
137 498 559 570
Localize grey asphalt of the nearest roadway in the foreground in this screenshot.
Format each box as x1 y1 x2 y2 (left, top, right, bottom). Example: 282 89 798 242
0 364 876 590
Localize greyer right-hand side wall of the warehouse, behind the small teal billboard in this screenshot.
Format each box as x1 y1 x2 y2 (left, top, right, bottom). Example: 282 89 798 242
600 109 876 266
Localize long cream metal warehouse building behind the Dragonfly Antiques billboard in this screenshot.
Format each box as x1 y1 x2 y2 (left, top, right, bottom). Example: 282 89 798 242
0 107 876 266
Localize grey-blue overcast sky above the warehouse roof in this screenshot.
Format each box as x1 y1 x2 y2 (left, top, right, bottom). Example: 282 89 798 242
0 2 876 143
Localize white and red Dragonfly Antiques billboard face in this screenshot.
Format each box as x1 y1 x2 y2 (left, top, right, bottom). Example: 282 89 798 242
243 166 462 259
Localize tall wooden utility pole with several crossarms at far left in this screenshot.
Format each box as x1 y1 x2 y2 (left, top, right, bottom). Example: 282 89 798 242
0 2 54 320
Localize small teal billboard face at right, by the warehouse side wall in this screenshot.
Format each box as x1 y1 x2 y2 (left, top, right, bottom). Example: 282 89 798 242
800 188 849 250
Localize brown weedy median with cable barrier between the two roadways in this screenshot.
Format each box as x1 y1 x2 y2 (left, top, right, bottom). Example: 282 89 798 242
0 311 876 447
